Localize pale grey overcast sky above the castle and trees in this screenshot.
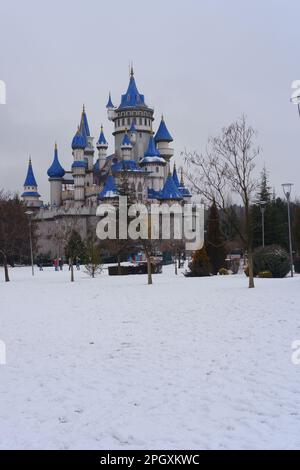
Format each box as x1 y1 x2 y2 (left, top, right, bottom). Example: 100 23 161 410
0 0 300 201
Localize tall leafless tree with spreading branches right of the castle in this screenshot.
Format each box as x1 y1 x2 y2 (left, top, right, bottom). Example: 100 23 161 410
185 116 259 288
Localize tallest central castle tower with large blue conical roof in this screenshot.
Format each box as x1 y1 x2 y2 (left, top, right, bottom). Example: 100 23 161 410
107 67 154 161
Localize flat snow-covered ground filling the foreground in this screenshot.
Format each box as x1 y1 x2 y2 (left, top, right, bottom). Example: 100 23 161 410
0 266 300 449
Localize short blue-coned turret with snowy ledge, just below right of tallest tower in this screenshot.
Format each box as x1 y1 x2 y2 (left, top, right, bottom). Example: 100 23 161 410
140 136 166 193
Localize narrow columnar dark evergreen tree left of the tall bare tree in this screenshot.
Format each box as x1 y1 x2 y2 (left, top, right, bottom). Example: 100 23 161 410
206 201 226 274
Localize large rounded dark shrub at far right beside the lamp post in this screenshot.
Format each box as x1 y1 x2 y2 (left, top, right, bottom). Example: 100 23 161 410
253 245 290 278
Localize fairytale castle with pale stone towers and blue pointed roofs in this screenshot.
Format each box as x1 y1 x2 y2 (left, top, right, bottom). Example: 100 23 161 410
21 67 191 253
